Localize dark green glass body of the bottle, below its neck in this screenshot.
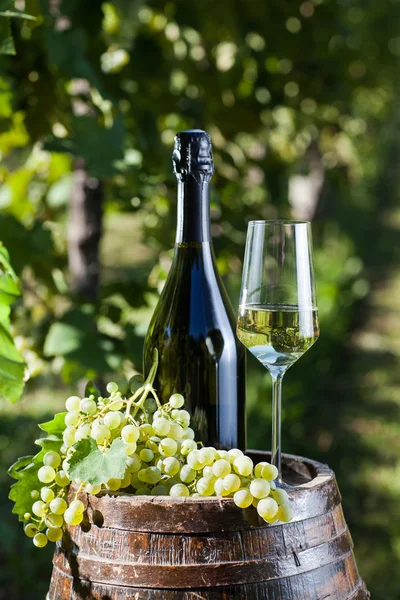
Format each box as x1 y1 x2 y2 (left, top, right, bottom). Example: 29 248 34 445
144 242 246 449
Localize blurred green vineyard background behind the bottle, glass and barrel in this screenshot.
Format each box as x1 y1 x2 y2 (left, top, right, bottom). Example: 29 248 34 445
0 0 400 600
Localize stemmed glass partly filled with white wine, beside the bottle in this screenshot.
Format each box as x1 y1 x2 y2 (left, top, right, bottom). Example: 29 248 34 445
237 220 319 484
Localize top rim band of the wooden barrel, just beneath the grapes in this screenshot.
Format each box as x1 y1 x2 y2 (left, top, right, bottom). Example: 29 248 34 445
71 451 341 533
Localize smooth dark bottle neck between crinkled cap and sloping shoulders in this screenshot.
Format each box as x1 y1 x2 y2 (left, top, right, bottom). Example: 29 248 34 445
176 181 211 244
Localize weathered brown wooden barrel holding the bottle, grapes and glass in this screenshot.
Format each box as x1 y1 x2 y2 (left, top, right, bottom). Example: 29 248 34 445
47 453 370 600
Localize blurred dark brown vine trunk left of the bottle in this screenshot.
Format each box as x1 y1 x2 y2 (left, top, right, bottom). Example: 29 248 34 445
68 159 104 302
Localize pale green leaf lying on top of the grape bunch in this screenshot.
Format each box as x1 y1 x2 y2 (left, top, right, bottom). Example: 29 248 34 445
69 438 128 485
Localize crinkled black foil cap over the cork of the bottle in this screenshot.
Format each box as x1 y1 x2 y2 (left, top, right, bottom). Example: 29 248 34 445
172 129 214 183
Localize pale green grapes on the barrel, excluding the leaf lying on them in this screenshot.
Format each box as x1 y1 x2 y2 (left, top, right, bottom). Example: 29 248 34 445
20 381 293 547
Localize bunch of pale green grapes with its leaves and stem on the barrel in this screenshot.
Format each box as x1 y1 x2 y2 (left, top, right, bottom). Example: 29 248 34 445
9 357 293 548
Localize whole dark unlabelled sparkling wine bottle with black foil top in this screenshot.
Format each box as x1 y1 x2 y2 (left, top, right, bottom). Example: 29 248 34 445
144 129 246 449
